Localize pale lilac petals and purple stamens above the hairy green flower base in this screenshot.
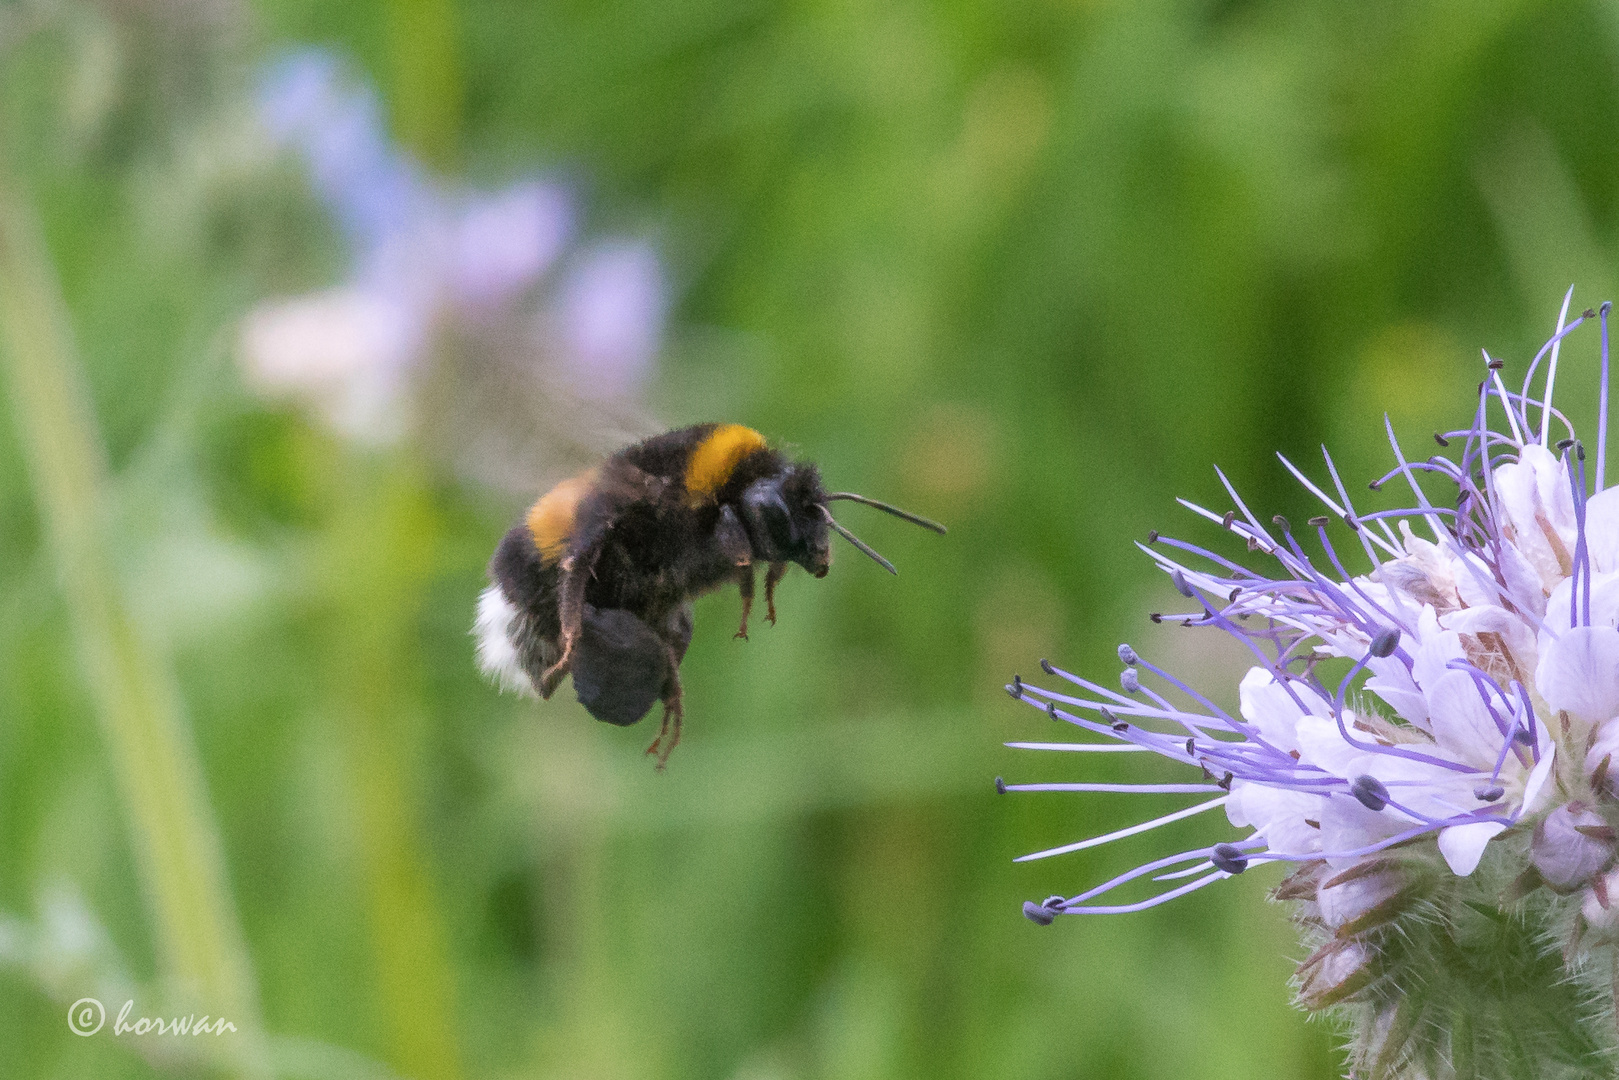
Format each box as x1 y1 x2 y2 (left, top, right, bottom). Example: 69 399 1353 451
1001 291 1619 928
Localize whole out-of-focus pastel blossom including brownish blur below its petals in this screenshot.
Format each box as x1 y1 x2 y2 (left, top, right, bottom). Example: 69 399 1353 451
243 50 667 472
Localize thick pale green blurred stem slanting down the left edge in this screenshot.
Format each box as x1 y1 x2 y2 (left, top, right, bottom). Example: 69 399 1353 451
0 178 269 1077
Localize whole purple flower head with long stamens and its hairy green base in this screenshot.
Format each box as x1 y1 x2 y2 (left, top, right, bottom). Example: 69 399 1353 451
996 290 1619 1078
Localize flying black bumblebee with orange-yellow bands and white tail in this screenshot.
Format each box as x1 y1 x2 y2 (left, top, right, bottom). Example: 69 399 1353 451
473 424 945 767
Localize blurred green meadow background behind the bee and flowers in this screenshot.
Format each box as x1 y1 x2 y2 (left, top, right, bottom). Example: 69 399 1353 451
0 0 1619 1080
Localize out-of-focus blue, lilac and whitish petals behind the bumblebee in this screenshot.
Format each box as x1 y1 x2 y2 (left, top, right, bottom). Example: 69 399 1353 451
243 50 667 440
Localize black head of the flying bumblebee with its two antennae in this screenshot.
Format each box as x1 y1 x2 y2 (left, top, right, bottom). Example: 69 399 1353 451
742 461 944 578
